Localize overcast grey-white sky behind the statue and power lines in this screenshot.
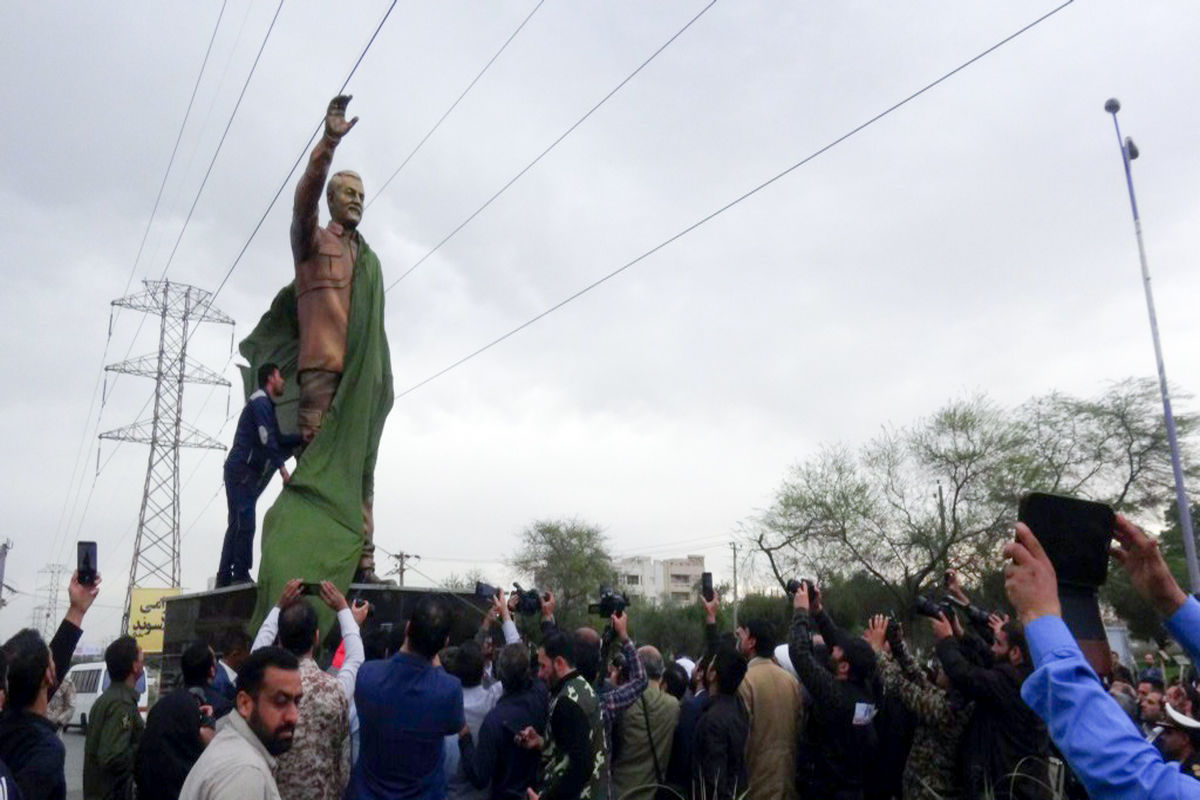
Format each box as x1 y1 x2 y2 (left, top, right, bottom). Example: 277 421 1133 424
0 0 1200 639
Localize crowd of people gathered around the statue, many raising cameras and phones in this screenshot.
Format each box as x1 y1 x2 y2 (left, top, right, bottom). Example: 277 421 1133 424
0 517 1200 800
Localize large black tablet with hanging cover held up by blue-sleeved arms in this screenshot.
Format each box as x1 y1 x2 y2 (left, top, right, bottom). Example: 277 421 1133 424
1016 492 1116 678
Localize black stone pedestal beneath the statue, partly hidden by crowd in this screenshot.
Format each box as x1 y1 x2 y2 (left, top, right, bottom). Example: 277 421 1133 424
160 583 488 691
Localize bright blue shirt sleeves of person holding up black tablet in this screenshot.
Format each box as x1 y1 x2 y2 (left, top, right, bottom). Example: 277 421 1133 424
1021 597 1200 800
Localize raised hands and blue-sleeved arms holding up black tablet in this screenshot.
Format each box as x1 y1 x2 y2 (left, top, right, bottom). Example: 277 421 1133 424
1004 515 1200 800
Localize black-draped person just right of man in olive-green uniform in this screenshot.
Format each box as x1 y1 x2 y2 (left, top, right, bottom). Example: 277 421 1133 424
133 688 204 800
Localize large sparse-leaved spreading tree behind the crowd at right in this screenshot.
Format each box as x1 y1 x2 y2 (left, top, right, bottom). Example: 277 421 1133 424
749 379 1195 618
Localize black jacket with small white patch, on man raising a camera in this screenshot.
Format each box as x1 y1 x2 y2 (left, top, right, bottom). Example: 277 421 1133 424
787 610 878 798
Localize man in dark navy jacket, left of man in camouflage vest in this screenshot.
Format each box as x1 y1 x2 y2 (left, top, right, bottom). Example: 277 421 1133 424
458 643 550 800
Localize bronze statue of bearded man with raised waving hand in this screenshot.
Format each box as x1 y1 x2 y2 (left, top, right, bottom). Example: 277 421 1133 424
292 95 386 582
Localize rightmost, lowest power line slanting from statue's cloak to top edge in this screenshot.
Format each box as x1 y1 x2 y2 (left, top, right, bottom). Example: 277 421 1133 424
389 0 1074 399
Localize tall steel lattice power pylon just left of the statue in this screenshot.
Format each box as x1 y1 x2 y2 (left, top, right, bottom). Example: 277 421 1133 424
100 281 234 631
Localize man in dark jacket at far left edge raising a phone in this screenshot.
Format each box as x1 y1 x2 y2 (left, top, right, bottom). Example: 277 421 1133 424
0 572 100 800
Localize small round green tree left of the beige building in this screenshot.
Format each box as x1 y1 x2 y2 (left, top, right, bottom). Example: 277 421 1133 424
509 519 616 627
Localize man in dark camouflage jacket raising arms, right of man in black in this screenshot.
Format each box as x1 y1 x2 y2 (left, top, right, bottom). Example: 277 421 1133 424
863 614 974 800
